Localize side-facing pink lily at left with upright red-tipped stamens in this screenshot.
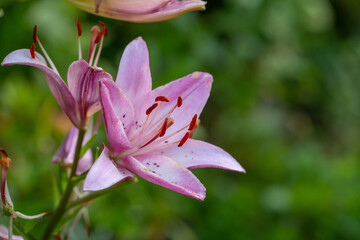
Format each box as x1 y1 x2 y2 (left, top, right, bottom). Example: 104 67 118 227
1 21 112 128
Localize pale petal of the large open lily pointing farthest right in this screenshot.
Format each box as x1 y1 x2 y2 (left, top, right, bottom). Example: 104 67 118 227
150 139 245 173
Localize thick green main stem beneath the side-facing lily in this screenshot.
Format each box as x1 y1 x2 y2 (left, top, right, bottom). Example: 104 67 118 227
41 129 85 240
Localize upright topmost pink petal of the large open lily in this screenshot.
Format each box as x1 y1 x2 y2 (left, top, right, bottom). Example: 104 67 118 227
116 37 151 103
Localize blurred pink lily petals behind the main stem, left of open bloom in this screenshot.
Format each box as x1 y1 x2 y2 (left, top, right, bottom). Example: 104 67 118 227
51 127 93 175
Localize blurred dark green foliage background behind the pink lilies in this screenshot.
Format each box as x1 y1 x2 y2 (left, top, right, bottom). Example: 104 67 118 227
0 0 360 240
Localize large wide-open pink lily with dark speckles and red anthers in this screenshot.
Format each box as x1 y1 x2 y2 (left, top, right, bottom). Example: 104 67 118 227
83 38 245 200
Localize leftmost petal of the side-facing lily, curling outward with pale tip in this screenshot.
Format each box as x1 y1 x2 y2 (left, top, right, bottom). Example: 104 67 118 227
1 49 80 127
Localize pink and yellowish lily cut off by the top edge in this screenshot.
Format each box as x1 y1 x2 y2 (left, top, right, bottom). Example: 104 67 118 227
68 0 206 22
